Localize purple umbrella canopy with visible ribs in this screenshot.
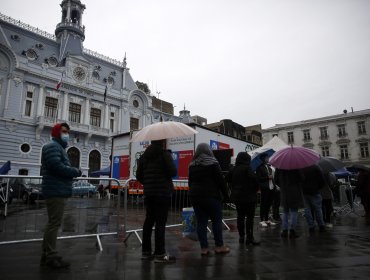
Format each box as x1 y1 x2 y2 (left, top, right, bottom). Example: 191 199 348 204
270 146 320 170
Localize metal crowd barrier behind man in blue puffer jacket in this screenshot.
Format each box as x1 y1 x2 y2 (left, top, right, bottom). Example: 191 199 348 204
0 175 125 251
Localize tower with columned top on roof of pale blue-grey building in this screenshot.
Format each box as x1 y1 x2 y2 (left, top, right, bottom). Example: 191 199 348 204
55 0 86 66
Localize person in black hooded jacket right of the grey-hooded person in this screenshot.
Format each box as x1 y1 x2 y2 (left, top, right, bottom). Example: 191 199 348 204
227 152 260 245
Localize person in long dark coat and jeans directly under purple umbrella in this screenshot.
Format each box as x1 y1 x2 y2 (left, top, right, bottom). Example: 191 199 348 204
274 169 303 239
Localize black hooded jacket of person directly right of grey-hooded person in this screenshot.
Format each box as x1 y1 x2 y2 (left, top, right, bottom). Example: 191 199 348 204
227 152 258 203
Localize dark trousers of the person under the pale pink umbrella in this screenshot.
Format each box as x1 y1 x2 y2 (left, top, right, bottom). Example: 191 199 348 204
142 196 171 255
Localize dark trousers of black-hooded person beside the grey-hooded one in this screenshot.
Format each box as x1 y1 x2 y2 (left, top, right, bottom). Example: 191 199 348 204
235 202 256 240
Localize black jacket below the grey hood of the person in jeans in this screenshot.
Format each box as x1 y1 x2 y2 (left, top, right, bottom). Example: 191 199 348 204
189 164 229 200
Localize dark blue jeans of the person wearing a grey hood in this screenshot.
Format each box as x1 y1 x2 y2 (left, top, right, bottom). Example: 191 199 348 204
190 198 224 249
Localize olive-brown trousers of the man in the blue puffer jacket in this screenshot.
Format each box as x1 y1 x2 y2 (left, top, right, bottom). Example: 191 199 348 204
42 197 66 259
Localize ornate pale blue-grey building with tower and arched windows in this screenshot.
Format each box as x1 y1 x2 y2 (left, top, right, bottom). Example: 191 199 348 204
0 0 179 175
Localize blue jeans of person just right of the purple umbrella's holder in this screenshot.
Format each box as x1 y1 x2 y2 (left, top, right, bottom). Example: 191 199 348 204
303 194 325 228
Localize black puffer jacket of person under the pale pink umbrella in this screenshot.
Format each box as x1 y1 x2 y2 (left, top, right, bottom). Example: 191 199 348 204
136 145 177 196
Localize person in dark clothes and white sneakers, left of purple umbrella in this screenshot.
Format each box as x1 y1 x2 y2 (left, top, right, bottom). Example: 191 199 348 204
256 154 276 227
